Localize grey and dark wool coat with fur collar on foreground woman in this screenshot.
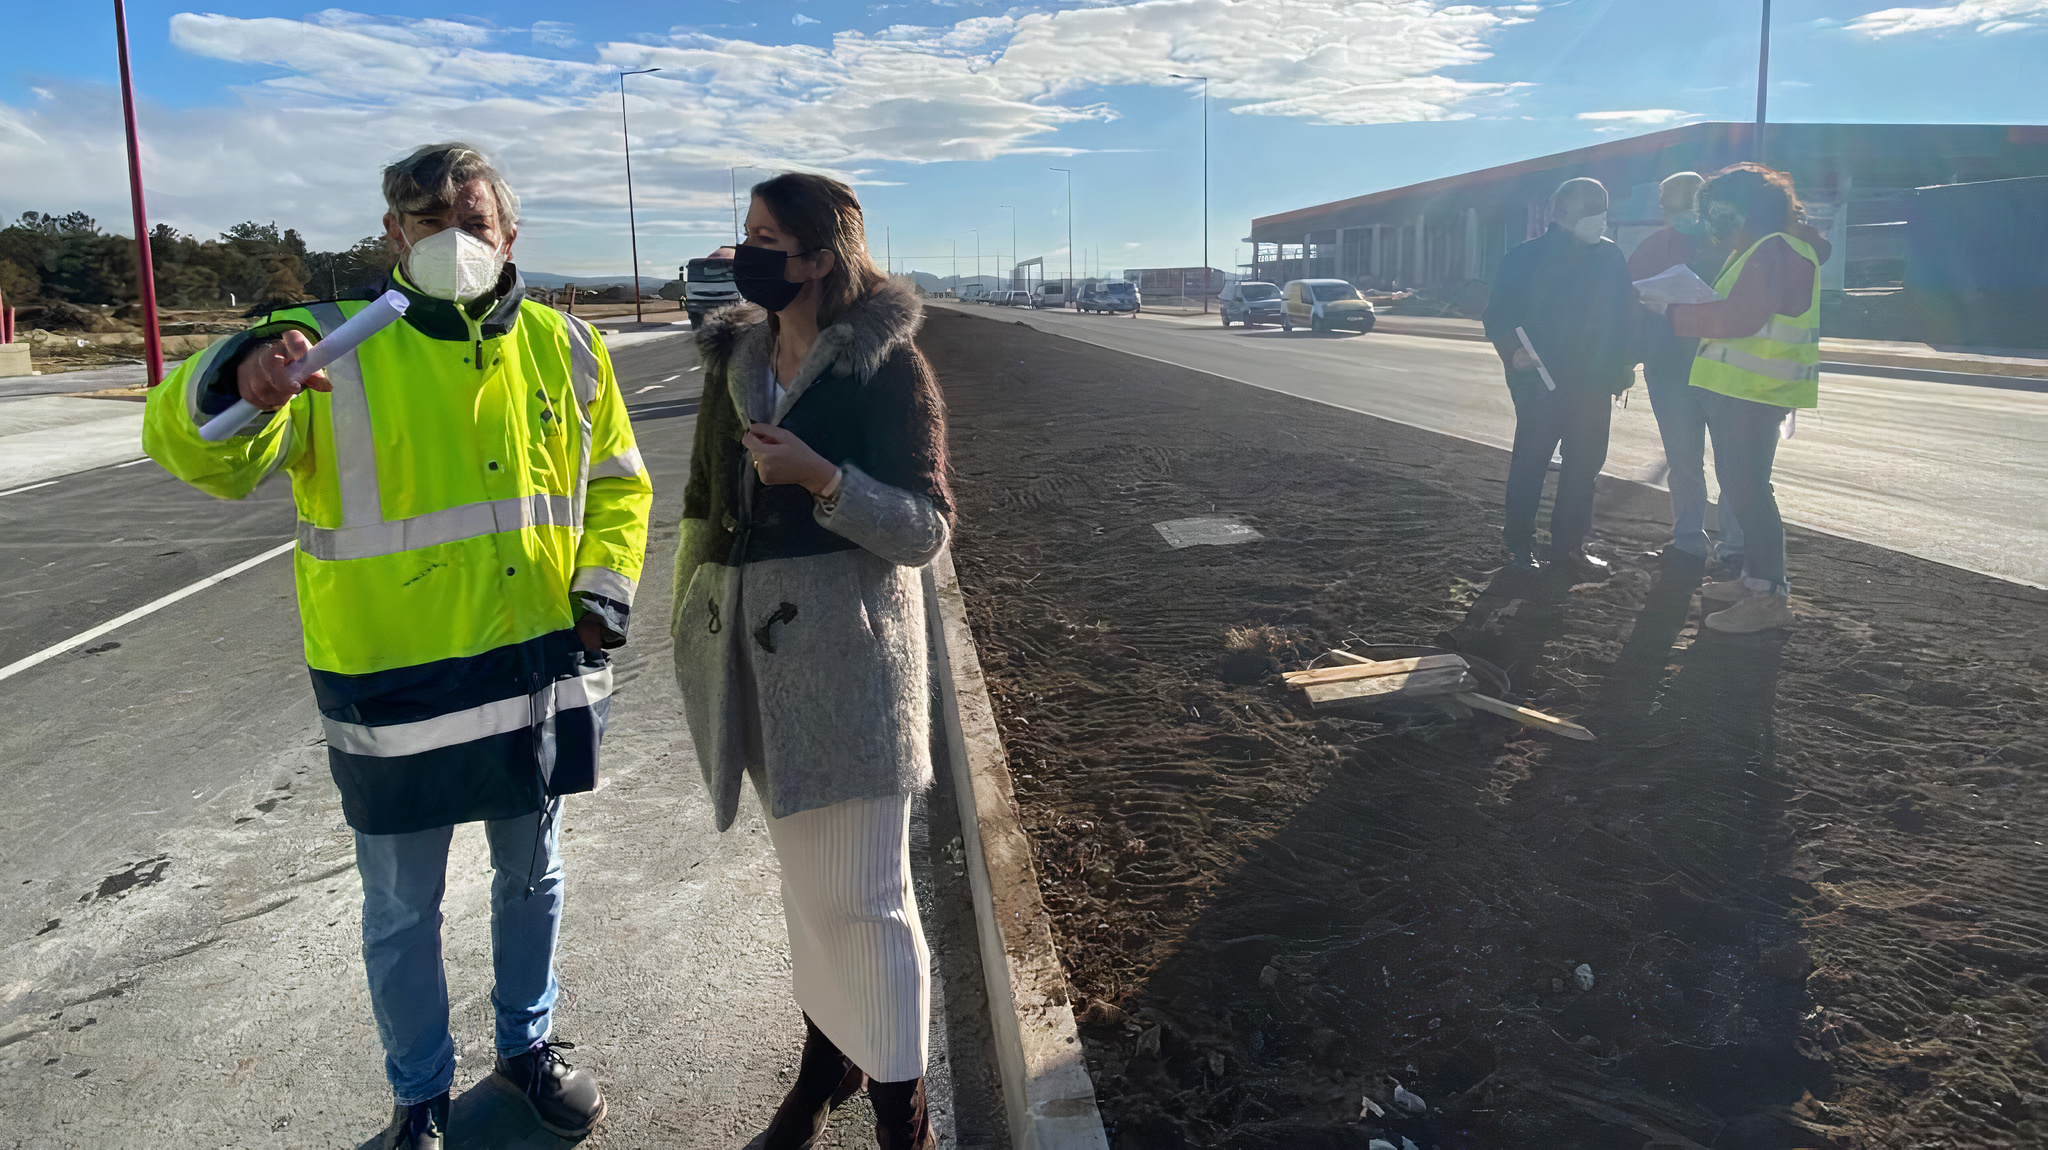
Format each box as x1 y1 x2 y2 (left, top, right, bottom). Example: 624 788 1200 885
670 282 952 831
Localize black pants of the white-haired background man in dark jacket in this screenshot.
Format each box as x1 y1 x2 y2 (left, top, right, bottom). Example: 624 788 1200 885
1505 383 1614 555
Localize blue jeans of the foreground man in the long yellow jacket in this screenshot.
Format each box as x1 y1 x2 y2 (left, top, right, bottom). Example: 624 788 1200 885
356 798 561 1105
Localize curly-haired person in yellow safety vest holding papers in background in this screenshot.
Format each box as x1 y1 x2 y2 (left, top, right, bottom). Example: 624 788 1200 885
1667 164 1825 632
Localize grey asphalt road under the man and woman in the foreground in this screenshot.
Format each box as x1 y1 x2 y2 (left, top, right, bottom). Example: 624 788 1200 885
0 327 1001 1146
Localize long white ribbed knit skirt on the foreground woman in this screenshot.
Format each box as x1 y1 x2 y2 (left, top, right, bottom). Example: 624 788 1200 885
762 796 932 1082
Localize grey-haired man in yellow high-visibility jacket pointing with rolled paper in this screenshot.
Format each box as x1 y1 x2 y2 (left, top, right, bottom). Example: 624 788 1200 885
143 143 653 1150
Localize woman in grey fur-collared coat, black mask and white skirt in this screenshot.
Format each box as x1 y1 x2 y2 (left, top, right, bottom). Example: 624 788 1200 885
672 174 952 1150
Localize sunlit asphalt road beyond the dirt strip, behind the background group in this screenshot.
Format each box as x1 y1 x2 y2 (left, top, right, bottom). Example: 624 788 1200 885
958 305 2048 587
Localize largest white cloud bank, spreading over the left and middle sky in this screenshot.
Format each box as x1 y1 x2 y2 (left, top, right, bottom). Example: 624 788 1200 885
0 0 1526 272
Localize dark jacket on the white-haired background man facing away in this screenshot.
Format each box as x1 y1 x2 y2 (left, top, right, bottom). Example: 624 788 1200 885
1485 223 1645 395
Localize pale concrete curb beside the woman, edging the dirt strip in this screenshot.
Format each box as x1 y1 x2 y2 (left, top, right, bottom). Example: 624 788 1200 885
924 552 1108 1150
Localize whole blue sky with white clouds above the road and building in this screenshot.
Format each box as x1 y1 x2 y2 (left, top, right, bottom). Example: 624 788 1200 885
0 0 2048 276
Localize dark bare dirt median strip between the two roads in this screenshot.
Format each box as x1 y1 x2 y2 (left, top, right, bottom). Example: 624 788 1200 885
922 311 2048 1150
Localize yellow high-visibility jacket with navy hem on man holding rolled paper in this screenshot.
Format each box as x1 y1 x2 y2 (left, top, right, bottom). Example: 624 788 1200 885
143 268 653 835
